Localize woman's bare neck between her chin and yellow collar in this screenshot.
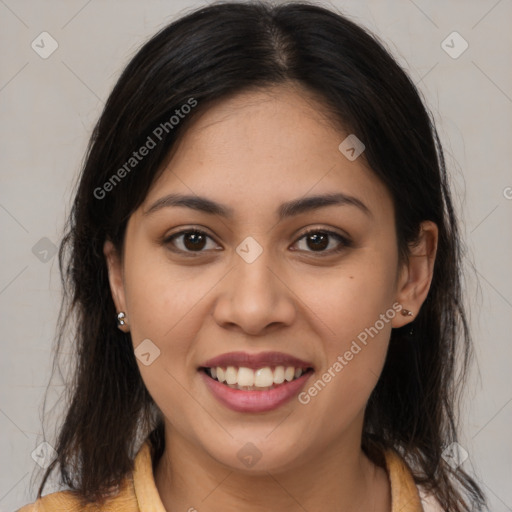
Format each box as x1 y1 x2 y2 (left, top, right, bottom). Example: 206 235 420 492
155 425 391 512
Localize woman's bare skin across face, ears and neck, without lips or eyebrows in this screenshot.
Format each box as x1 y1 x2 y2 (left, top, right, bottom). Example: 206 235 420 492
104 85 437 512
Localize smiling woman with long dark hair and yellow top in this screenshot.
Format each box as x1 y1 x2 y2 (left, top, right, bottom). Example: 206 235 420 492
17 3 485 512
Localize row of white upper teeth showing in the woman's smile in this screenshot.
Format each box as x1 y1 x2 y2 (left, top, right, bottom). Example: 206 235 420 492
209 366 304 390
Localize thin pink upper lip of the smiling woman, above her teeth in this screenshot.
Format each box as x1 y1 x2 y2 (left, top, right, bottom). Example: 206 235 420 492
201 352 313 370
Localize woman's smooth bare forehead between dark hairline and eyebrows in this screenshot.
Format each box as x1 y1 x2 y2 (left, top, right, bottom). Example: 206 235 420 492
144 86 392 221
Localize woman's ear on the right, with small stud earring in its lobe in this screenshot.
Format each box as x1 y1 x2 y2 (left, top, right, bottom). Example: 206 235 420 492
391 220 439 327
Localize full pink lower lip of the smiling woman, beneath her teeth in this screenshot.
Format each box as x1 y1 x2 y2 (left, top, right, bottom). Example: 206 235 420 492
200 370 313 412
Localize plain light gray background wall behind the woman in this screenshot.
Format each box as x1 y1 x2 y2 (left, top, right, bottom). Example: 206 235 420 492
0 0 512 512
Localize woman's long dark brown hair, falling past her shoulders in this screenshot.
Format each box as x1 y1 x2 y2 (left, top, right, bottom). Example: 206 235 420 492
38 2 485 512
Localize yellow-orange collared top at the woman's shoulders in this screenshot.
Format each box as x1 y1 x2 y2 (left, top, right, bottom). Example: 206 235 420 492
16 440 428 512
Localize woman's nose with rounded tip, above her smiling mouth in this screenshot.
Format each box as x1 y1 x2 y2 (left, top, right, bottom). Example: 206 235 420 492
213 251 296 336
